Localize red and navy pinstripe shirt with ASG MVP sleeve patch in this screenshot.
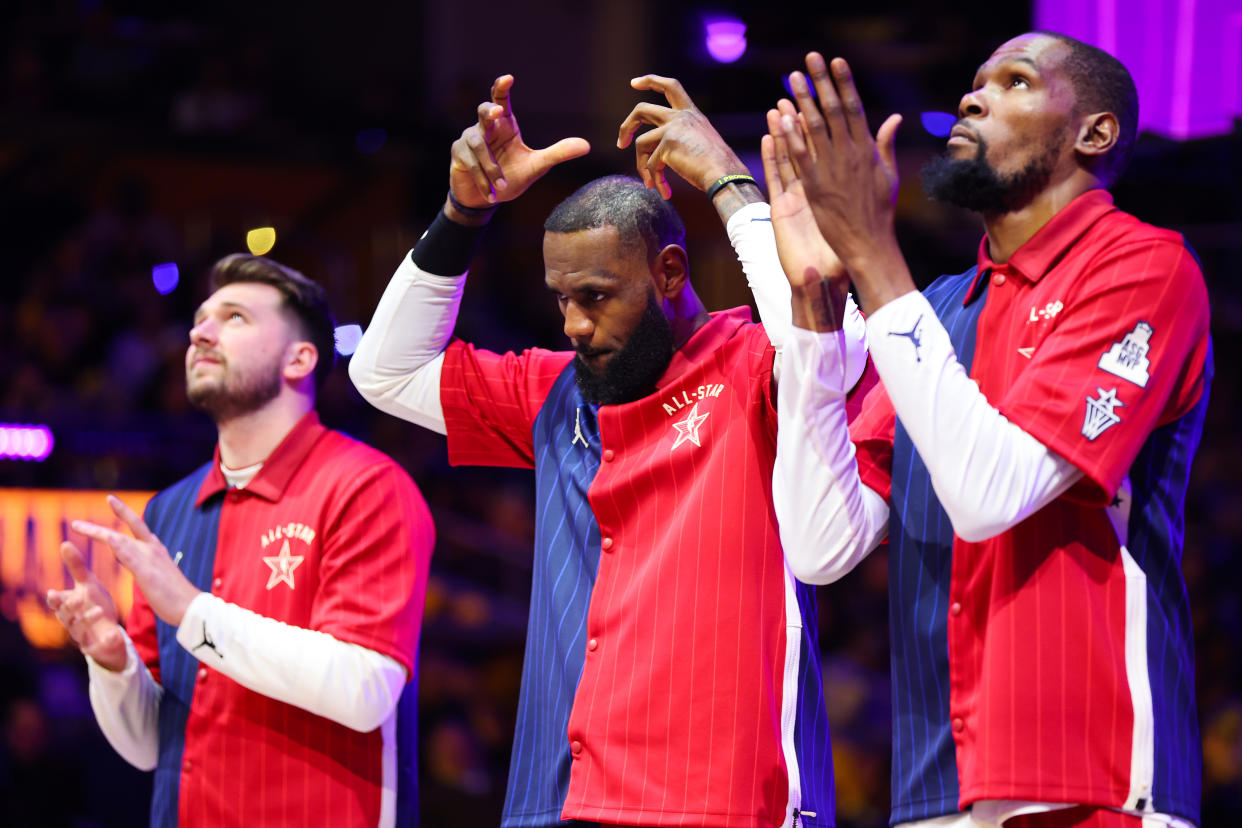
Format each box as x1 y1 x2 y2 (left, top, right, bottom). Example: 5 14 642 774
852 190 1211 822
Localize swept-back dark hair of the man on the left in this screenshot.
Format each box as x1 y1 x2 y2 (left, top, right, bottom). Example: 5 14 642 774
207 253 337 391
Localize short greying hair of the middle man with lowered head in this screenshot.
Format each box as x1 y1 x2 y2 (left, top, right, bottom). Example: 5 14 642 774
544 175 686 261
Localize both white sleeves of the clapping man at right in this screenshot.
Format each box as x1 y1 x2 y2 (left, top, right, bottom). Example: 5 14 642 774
774 292 1082 583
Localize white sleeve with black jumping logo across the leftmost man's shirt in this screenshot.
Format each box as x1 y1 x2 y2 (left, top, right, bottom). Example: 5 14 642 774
176 592 406 732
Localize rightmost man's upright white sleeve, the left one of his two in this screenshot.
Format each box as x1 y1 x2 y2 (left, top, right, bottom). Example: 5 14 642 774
773 328 888 583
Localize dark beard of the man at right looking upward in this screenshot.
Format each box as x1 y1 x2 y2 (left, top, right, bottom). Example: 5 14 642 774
922 133 1057 216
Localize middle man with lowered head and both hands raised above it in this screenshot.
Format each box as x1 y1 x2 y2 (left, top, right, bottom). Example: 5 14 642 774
350 76 864 828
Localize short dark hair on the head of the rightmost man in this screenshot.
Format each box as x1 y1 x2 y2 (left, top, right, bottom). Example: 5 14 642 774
1036 31 1139 184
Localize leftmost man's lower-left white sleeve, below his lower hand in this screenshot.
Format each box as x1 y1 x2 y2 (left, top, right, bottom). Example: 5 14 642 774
86 631 164 771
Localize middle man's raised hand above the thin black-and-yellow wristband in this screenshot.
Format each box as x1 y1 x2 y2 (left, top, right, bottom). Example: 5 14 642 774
617 74 748 199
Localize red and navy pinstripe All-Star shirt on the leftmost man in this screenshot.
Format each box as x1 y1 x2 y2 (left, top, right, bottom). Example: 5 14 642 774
130 412 432 826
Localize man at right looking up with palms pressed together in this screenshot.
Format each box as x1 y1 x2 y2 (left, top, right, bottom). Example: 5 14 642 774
764 32 1212 828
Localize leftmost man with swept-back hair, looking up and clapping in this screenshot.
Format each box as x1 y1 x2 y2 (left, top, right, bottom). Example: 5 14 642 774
47 254 433 826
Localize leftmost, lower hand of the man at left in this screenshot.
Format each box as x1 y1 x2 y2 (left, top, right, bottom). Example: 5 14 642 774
47 541 127 672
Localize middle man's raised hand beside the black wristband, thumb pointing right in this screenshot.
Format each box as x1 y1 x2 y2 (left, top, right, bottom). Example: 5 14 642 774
448 74 591 209
